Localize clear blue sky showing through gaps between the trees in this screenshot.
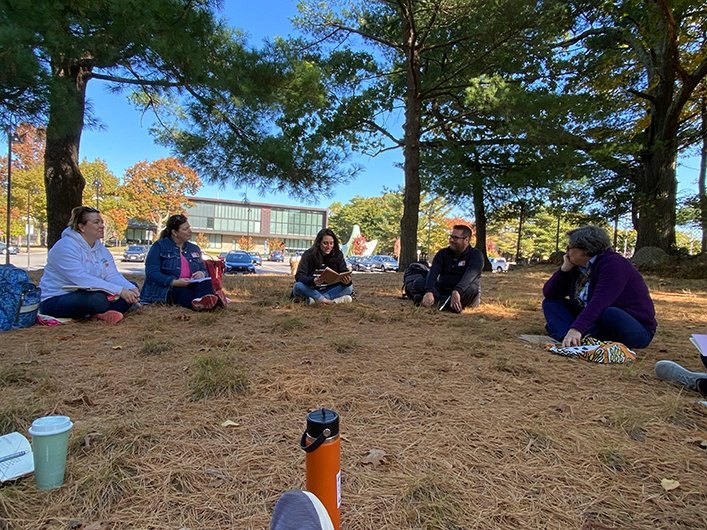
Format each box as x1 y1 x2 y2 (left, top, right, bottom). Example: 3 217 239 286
80 0 699 215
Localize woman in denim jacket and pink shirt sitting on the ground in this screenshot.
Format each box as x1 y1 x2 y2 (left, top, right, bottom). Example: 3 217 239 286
141 215 220 311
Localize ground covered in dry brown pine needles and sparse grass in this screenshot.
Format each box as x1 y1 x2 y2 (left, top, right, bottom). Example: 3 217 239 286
0 267 707 530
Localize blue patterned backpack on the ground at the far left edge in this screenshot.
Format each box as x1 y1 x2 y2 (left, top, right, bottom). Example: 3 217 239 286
0 265 41 331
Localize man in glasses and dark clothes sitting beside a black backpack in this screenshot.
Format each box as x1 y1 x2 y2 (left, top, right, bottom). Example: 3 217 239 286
406 225 484 313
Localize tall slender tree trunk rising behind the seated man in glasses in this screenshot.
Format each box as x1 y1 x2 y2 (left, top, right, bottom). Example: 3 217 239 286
398 3 422 270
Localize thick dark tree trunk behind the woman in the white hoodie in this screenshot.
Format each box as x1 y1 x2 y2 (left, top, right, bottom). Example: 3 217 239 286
44 62 89 248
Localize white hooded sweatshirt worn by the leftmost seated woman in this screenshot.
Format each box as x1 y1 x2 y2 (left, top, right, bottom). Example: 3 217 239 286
39 227 135 301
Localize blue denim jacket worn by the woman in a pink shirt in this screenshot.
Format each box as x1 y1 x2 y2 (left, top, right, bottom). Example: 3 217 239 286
140 237 206 304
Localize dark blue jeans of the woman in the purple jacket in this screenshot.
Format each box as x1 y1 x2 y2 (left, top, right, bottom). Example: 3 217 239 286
543 298 654 348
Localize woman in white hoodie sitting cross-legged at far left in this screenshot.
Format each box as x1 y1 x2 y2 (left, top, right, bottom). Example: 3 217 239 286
39 206 140 324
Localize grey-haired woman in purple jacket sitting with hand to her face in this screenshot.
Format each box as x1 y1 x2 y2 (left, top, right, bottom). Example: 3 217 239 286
543 225 657 348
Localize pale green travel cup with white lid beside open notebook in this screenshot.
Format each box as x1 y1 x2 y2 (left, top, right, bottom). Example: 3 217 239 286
29 416 74 490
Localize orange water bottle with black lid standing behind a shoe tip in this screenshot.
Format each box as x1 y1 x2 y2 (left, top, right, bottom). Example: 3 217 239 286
300 409 341 530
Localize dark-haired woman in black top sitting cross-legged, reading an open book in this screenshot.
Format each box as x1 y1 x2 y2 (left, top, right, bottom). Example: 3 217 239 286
292 228 353 304
